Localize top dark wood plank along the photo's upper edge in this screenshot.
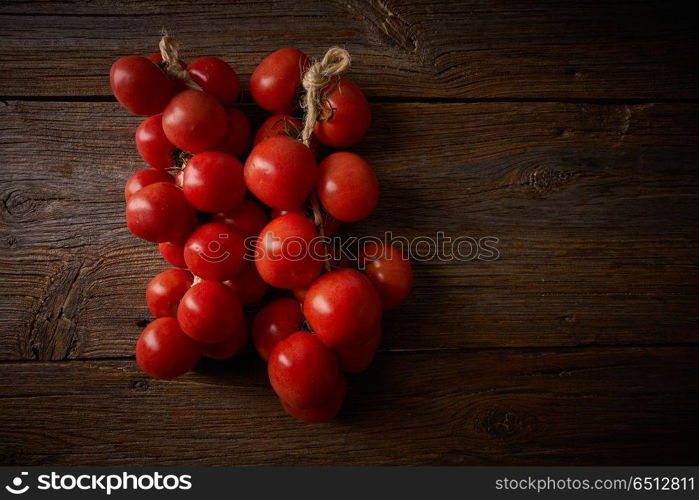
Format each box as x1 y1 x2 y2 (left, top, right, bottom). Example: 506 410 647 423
0 0 699 99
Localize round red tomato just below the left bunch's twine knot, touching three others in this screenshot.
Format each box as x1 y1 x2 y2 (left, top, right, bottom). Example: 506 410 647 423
162 89 228 154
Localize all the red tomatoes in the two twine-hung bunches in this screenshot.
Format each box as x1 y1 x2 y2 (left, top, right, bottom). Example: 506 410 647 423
110 41 412 422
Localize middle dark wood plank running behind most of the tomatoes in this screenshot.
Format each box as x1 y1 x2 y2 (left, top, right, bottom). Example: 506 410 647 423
0 102 699 359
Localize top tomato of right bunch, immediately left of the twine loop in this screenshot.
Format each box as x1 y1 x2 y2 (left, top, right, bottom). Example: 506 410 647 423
250 48 311 115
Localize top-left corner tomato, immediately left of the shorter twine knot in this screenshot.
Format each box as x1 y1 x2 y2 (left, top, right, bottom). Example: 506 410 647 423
109 56 177 116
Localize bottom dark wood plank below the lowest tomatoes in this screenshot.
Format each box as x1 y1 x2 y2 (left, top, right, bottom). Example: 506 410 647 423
0 347 699 466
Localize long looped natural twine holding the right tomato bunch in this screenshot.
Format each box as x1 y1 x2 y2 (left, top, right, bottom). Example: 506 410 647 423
301 47 351 272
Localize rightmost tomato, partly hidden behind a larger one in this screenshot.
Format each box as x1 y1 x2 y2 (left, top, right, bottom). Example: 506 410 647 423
359 242 413 309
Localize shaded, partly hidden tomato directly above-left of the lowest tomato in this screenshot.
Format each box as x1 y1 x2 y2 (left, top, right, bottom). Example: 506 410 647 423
252 298 303 361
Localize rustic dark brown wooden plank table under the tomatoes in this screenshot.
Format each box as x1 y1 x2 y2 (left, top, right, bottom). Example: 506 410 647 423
0 0 699 465
